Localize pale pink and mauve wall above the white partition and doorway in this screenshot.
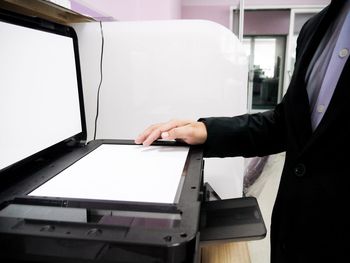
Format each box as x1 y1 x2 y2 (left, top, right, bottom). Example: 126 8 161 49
71 0 330 30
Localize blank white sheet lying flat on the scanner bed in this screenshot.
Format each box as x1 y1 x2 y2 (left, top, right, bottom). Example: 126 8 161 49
29 144 189 203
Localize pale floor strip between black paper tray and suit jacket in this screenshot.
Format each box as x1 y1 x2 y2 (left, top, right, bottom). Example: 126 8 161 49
247 153 285 263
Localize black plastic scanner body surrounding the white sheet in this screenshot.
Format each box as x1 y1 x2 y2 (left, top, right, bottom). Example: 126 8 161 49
0 140 203 262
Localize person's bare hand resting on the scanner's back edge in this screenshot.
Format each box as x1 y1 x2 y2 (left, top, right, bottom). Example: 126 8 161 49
135 120 207 146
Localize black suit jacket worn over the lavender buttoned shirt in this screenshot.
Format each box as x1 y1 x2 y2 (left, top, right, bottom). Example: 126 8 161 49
203 0 350 263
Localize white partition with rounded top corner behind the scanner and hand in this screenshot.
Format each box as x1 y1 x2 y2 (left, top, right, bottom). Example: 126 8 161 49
75 20 247 198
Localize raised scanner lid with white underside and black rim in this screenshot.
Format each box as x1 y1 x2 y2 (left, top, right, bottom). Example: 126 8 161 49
0 9 87 172
